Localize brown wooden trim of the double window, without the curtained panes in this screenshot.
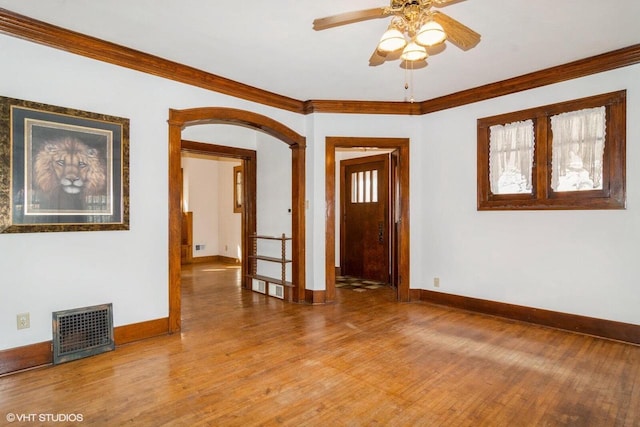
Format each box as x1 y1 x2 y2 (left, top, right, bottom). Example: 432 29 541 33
477 90 626 210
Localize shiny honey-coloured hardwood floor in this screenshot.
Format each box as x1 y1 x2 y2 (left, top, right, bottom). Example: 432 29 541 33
0 264 640 426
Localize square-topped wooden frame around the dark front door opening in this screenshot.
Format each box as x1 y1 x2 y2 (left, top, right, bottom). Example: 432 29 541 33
325 136 411 302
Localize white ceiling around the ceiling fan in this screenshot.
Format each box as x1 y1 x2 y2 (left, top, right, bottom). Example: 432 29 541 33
0 0 640 101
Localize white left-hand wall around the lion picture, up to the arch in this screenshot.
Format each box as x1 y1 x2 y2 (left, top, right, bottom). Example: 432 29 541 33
0 35 305 350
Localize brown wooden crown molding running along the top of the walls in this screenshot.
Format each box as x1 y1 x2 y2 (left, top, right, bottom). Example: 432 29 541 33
0 8 640 115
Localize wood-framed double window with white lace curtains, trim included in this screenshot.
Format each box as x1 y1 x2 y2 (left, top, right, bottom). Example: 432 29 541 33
478 91 626 210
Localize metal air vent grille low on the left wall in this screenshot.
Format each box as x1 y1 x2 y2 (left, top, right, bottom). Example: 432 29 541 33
53 304 115 364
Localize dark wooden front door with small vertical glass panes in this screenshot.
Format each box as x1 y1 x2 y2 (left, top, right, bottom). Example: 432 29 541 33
340 154 390 283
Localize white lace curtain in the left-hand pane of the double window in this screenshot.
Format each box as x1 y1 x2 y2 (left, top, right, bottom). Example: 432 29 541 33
489 120 535 194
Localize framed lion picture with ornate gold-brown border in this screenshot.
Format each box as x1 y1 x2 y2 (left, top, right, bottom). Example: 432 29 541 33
0 97 129 233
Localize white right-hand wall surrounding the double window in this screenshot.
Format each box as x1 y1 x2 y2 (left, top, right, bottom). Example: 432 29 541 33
411 65 640 324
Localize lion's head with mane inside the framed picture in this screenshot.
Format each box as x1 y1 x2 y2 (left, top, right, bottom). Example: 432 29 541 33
34 138 106 202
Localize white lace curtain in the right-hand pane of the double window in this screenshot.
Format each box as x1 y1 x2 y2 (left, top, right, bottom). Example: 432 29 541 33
551 107 606 191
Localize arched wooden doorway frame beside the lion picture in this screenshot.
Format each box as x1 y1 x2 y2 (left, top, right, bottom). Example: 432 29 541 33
168 107 306 333
